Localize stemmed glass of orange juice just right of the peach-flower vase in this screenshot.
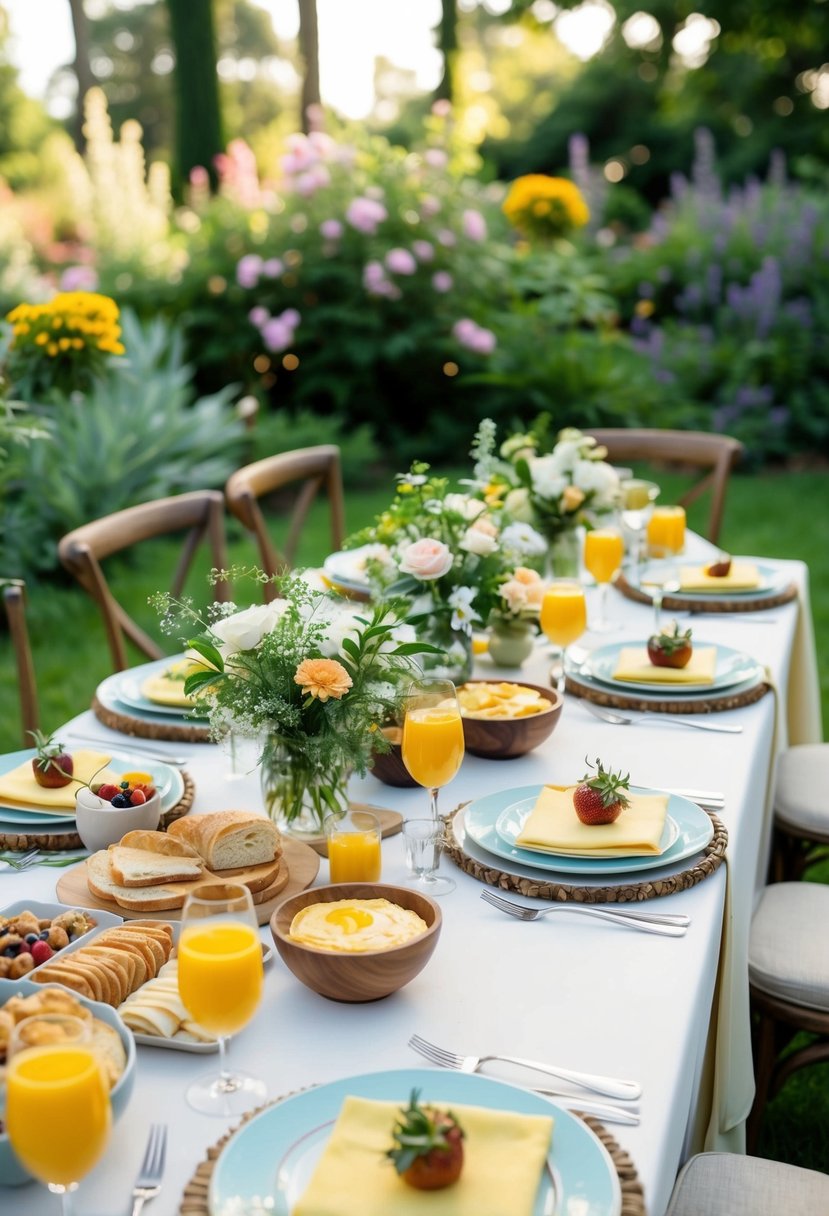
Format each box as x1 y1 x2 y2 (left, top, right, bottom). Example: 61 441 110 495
401 679 463 823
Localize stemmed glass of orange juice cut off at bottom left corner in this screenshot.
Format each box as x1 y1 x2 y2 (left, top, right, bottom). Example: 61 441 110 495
6 1013 112 1216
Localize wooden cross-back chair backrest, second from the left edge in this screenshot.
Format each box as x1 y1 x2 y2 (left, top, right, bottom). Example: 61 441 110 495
57 490 230 671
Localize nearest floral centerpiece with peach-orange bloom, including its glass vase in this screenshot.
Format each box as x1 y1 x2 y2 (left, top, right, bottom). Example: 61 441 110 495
154 570 428 833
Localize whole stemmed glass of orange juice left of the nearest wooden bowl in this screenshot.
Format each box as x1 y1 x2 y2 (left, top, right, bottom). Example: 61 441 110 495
179 882 265 1116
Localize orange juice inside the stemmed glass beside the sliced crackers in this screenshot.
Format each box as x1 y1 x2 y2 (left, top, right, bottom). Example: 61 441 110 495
179 921 263 1035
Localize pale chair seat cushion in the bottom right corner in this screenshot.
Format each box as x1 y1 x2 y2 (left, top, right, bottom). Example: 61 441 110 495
665 1153 829 1216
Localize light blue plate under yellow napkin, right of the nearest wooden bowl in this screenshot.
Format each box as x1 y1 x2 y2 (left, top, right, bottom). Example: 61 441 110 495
463 786 714 874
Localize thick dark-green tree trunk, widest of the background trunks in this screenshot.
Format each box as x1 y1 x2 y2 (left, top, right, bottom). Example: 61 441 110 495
167 0 224 197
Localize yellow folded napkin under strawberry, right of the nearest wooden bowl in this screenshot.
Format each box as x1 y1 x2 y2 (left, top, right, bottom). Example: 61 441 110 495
515 786 667 857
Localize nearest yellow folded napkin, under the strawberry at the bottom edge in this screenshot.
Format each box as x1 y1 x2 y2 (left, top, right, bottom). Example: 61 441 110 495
292 1094 553 1216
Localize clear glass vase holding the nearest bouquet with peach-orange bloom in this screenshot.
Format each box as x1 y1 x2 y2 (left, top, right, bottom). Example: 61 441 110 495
260 737 351 837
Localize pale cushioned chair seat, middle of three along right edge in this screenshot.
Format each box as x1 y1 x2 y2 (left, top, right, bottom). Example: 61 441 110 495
749 883 829 1011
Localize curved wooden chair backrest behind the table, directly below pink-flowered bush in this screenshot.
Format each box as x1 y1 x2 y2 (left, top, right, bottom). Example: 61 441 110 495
225 444 345 599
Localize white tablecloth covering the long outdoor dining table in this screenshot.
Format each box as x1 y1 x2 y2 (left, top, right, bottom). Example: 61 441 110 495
6 539 820 1216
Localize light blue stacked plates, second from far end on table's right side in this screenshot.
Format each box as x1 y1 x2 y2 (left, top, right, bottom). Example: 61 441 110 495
565 638 765 702
